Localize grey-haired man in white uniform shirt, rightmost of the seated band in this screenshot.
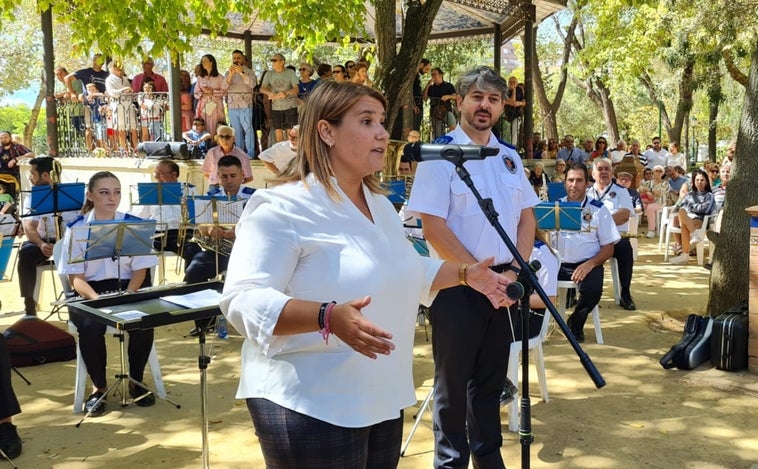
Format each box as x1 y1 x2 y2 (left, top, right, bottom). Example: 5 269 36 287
587 159 637 311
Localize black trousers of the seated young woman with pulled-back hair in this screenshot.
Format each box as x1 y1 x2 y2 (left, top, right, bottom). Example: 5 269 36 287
69 278 155 388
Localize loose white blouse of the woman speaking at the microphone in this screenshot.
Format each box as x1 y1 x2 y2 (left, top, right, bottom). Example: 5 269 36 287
221 176 441 428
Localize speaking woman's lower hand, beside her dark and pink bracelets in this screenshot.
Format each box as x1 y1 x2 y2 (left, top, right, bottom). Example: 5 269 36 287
329 296 395 359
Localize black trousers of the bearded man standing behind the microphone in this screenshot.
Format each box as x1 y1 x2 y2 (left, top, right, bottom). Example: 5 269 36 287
430 286 516 469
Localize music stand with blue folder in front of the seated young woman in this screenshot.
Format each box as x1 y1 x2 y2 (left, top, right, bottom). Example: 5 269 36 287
69 220 180 427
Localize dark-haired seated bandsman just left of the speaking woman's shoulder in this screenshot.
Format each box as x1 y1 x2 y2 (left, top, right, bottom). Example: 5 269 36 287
184 155 255 283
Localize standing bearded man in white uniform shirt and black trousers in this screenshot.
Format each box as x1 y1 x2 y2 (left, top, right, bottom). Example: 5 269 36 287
407 67 539 468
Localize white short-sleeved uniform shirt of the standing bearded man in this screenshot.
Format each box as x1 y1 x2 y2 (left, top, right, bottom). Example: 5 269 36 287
405 126 540 264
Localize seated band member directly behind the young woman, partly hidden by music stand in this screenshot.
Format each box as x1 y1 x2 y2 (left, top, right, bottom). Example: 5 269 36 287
130 159 195 265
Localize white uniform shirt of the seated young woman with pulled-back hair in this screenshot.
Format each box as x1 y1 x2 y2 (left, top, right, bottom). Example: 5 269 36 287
58 211 158 282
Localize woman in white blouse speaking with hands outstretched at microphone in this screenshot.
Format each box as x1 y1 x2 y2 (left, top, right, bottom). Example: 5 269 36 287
221 81 511 468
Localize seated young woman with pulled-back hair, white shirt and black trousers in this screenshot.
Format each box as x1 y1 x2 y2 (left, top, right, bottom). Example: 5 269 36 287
58 171 158 416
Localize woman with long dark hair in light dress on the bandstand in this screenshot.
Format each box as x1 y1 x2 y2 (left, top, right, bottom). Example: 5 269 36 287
195 54 229 136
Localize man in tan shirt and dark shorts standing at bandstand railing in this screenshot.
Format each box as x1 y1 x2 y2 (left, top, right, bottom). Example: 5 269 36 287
261 54 298 142
